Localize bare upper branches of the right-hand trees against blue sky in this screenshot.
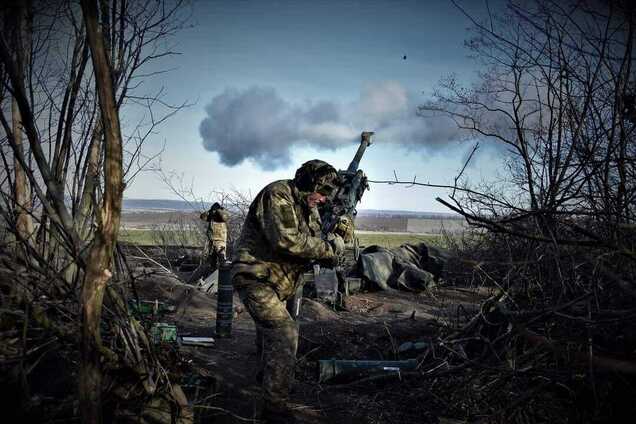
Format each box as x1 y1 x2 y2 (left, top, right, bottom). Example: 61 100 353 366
420 0 636 243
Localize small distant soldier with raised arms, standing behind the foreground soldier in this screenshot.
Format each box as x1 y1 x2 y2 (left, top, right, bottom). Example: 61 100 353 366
190 202 229 283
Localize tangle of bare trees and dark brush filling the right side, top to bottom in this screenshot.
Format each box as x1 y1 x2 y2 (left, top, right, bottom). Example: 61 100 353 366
412 0 636 422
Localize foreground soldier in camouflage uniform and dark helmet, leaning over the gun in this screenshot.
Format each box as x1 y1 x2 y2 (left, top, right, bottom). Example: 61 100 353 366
232 160 344 422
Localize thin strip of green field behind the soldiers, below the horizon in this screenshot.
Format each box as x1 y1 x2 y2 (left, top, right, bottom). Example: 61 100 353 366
119 229 443 247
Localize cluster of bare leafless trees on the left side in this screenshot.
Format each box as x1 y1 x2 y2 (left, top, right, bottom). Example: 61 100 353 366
0 0 188 422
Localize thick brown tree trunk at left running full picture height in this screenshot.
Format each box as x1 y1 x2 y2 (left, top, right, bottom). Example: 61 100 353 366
79 0 123 423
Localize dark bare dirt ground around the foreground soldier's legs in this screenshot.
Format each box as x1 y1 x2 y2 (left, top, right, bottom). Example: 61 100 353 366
130 264 488 424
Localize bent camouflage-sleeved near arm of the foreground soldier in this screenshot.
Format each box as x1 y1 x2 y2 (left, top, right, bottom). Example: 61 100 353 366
263 191 334 259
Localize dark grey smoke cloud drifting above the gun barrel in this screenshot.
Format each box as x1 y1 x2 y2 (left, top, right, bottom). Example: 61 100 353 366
199 82 458 170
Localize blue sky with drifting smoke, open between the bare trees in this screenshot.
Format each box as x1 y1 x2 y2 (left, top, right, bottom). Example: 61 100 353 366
125 0 498 212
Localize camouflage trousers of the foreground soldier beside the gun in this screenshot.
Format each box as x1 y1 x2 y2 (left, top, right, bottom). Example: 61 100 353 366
235 276 298 407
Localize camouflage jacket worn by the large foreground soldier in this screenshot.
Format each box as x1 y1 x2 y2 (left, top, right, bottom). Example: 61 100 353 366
232 180 334 300
